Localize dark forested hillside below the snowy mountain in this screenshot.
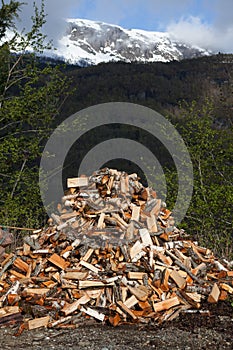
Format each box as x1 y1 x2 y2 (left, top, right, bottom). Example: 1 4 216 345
59 54 233 129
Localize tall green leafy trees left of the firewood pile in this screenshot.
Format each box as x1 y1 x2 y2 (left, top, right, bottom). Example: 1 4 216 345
0 1 69 227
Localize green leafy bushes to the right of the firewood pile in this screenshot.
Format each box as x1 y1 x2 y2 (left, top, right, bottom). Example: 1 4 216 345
173 100 233 256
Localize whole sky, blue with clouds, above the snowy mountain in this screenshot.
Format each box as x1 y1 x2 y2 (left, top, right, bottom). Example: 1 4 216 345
6 0 233 53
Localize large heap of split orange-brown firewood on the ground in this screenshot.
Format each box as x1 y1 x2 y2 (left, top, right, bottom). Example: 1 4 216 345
0 168 233 334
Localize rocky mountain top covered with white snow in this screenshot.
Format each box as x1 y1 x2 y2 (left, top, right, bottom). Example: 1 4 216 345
48 19 210 65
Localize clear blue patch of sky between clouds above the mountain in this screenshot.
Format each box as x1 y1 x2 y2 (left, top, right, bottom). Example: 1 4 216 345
70 0 217 31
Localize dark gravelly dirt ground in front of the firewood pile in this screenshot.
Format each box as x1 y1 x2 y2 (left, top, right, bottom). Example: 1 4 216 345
0 302 233 350
